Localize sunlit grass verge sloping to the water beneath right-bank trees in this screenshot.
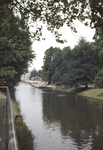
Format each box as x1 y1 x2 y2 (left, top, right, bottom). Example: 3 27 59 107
57 87 103 100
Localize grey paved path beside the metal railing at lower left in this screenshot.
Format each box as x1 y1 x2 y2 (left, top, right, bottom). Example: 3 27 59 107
0 99 6 150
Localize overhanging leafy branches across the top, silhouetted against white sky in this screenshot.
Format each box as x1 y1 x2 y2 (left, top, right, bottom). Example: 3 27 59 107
0 0 103 42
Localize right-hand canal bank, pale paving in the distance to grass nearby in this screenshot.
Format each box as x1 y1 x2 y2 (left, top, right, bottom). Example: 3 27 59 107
26 80 103 100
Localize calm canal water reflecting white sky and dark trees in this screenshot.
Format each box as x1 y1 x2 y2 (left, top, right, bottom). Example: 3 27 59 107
15 83 103 150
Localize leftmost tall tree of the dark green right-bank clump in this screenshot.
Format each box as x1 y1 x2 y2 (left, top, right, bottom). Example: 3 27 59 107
42 47 62 84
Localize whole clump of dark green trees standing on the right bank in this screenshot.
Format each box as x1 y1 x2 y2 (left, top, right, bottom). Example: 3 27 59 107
43 38 100 87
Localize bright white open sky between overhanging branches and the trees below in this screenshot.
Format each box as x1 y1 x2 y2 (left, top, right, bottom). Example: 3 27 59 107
29 21 95 71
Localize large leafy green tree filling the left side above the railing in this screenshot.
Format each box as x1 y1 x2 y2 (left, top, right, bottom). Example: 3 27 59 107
0 5 35 87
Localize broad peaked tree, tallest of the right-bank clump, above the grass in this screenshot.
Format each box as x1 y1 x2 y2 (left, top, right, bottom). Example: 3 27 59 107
68 39 99 87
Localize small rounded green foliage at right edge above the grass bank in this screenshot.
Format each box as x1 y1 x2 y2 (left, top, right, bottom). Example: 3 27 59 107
95 68 103 88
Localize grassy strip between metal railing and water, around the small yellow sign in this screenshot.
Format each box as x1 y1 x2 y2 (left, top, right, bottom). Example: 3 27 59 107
11 100 34 150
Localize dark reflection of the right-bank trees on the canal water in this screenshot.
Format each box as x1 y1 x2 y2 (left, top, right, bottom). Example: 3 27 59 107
43 92 103 150
